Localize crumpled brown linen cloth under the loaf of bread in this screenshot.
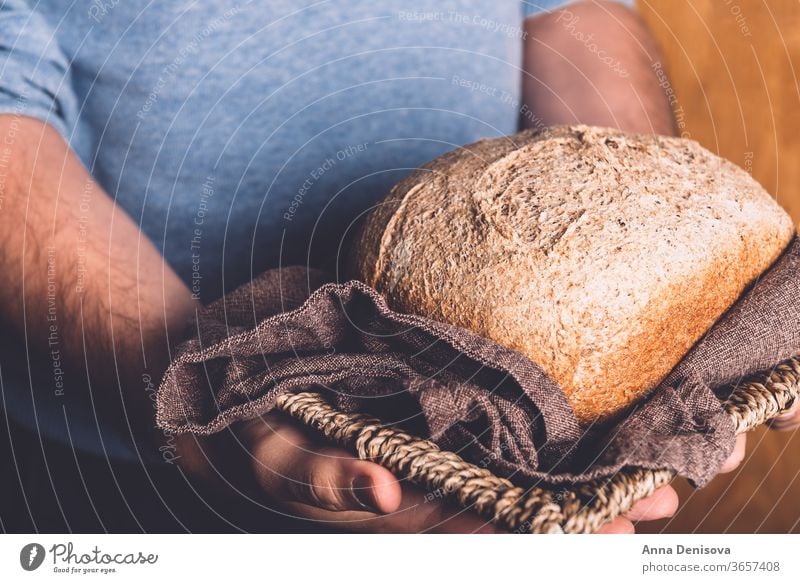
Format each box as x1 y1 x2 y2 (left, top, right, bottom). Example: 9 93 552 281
157 238 800 486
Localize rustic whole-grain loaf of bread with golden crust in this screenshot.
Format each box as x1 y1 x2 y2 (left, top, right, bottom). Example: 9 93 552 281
351 126 794 423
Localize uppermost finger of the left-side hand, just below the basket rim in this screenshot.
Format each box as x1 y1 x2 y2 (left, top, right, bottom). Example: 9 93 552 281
244 417 402 513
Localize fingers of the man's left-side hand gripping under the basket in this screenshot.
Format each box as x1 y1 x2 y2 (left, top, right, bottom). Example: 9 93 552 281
244 414 494 532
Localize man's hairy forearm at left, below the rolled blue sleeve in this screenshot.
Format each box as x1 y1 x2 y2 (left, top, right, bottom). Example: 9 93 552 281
0 115 194 448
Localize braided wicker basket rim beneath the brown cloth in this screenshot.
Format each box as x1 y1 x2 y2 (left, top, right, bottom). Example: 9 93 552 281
277 356 800 533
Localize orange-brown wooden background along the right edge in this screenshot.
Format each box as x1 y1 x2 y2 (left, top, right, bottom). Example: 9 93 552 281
638 0 800 532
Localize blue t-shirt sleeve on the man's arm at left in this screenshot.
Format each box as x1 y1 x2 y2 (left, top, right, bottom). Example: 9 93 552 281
0 0 78 141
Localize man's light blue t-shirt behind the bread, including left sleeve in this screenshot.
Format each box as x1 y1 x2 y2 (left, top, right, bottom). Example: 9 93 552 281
0 0 632 464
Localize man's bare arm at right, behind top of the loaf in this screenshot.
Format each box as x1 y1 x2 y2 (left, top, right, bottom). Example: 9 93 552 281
522 2 675 135
